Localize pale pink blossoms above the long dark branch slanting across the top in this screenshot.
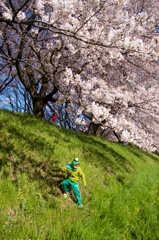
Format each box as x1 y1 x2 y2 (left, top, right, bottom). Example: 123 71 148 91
0 0 159 61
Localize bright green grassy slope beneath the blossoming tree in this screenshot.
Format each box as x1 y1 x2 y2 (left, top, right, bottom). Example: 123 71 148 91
0 110 159 240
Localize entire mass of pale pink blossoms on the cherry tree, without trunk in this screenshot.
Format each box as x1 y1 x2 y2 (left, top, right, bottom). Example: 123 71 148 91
0 0 159 151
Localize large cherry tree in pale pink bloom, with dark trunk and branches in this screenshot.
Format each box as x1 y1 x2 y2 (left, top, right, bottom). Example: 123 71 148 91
0 0 159 151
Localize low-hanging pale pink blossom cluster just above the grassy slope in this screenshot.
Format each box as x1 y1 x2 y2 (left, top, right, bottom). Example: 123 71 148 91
61 69 159 151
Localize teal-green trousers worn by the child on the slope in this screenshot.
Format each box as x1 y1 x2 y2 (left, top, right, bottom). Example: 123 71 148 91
62 179 82 206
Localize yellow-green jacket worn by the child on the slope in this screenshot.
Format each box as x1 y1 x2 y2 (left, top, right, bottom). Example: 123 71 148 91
58 164 86 186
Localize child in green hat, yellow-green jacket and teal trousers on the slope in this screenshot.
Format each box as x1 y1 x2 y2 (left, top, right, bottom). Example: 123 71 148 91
53 158 86 207
